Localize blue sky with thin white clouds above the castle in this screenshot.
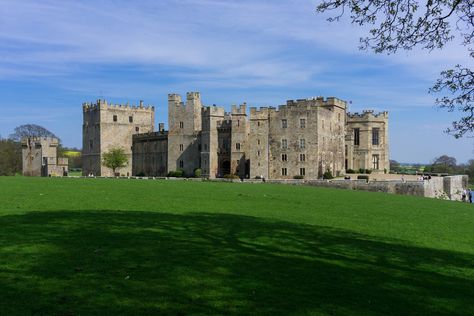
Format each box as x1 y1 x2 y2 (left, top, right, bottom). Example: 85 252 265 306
0 0 474 163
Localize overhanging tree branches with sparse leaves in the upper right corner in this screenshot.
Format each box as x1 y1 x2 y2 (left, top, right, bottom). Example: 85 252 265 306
316 0 474 138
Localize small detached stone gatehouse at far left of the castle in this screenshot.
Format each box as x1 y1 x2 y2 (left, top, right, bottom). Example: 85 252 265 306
21 137 68 177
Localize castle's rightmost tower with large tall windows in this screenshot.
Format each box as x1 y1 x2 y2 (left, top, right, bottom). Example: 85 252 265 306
345 111 390 172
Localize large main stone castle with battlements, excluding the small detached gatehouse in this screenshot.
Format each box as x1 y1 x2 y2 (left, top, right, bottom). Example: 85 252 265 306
83 92 389 179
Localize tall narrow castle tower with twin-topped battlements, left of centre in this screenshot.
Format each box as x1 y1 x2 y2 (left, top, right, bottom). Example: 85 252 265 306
168 92 202 175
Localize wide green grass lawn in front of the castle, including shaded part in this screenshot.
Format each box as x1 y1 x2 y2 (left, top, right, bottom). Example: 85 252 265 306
0 177 474 315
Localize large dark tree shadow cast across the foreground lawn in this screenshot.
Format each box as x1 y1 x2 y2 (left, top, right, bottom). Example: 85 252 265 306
0 211 474 315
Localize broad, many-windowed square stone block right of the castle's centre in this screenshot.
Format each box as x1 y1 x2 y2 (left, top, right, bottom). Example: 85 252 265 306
249 97 346 179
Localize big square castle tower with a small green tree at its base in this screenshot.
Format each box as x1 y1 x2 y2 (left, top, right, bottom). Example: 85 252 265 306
82 100 155 176
